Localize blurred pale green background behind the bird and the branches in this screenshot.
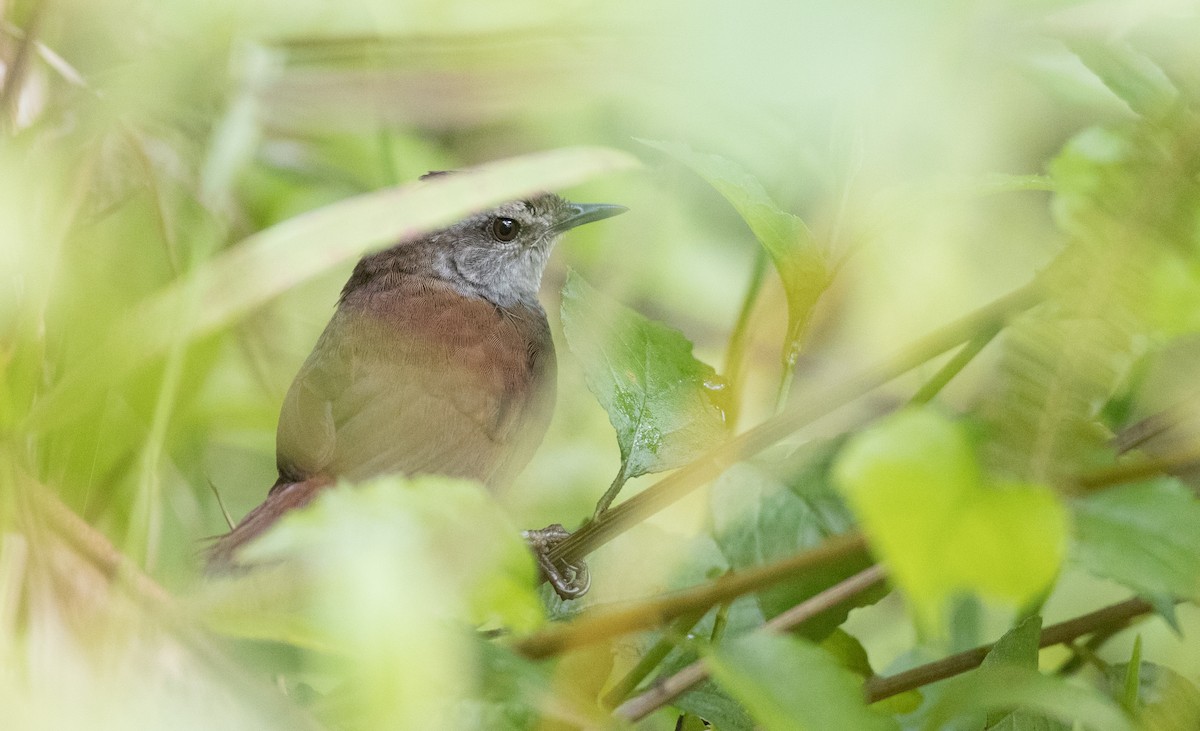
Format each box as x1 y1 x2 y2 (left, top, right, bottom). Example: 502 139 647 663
0 0 1200 727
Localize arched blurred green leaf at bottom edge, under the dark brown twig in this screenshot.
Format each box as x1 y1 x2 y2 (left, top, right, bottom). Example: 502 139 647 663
923 664 1133 731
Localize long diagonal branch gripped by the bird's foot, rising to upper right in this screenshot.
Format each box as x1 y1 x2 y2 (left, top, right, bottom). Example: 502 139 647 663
550 281 1042 564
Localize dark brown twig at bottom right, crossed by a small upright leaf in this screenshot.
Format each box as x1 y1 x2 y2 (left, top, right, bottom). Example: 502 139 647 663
863 598 1154 703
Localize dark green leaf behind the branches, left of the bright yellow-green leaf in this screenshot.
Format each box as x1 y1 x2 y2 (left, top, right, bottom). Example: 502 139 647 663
709 444 886 641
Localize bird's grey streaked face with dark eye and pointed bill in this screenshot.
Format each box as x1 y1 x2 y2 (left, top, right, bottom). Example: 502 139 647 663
439 193 626 307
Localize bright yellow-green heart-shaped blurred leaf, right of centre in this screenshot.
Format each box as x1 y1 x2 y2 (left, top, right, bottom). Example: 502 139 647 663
834 409 1067 629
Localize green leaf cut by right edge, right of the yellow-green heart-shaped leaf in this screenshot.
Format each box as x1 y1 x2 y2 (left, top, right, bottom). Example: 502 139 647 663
1074 479 1200 598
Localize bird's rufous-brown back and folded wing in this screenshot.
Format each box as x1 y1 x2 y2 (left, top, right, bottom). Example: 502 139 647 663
278 282 548 481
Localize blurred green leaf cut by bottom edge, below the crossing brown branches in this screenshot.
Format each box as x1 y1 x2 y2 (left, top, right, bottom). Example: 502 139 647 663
708 633 899 731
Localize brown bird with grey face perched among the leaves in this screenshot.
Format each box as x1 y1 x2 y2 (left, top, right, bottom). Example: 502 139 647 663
206 172 628 598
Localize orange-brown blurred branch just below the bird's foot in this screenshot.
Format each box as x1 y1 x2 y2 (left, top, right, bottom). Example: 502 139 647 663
514 533 866 659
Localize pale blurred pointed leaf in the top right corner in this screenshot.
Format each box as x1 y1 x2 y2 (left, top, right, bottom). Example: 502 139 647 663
1067 37 1180 119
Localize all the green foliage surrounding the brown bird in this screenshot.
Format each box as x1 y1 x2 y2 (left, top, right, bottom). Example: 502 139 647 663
7 0 1200 731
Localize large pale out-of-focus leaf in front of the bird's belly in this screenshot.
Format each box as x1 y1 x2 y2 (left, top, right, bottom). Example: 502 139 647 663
198 477 542 729
